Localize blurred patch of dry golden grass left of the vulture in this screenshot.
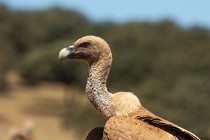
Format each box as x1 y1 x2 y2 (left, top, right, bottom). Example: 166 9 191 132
0 77 85 140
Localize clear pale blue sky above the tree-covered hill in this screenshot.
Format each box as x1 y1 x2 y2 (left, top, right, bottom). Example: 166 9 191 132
0 0 210 28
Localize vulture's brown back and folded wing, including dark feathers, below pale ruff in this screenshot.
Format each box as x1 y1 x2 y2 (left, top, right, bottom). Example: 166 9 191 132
104 107 199 140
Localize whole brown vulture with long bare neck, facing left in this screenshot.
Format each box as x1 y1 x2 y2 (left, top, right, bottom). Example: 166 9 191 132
59 36 199 140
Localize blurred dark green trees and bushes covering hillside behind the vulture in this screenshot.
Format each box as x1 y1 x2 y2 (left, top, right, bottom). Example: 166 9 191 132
0 5 210 140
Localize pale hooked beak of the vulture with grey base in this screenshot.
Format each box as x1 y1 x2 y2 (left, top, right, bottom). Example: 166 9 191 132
58 45 74 62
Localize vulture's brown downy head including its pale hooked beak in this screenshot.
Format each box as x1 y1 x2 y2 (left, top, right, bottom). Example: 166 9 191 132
58 36 112 63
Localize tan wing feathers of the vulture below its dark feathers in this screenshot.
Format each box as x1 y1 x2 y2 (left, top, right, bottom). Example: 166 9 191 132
104 116 176 140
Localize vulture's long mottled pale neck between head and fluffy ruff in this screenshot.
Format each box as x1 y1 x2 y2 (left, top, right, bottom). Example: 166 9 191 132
86 55 113 118
